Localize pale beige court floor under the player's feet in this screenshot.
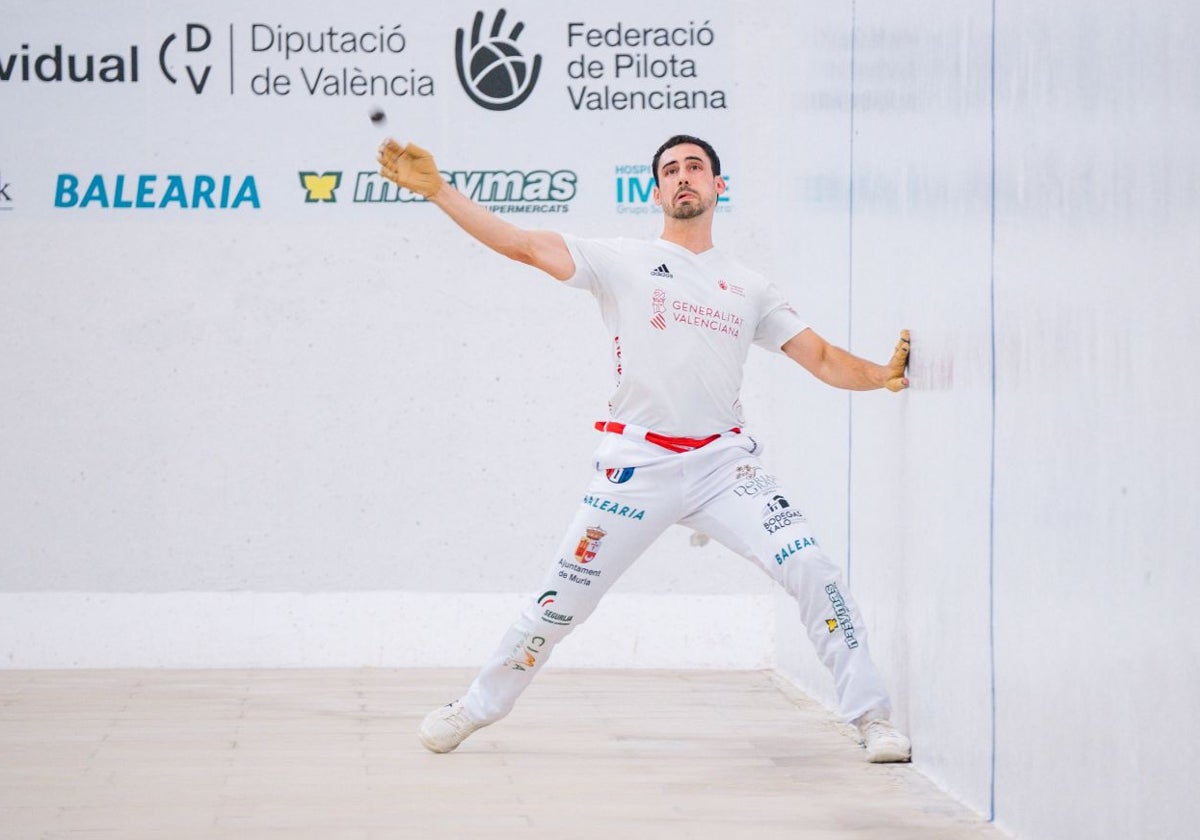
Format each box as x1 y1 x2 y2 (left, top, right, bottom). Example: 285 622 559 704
0 668 1004 840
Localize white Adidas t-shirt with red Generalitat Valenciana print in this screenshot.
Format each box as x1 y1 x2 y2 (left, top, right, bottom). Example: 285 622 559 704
563 235 808 437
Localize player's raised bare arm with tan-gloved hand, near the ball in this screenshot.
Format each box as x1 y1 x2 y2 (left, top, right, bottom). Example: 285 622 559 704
378 139 575 280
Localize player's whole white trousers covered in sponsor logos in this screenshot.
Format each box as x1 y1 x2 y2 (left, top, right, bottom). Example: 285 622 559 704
463 434 890 722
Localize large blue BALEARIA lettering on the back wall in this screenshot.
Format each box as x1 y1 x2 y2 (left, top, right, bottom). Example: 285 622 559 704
54 173 260 210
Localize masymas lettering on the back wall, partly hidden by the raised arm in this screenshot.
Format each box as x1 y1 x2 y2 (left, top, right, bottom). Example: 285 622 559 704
354 169 578 214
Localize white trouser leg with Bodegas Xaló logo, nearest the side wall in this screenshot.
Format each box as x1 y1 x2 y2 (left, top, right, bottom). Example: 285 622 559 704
683 449 892 721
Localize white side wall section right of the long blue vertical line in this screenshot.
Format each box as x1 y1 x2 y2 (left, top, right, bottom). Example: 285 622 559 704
995 2 1200 836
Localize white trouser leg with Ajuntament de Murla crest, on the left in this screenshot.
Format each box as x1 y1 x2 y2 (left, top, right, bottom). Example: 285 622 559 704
463 467 678 724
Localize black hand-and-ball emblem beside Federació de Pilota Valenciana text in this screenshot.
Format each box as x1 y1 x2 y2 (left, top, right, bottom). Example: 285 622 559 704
455 8 541 110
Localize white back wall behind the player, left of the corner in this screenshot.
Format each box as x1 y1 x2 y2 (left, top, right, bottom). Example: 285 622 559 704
0 2 773 667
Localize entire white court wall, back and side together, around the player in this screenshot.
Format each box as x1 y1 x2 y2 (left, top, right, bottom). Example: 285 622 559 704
0 0 1200 840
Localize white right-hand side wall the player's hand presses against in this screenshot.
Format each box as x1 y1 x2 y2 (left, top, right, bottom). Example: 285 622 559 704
780 0 1200 839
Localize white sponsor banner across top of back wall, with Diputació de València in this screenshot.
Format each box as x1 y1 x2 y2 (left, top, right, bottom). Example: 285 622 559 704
0 0 738 222
